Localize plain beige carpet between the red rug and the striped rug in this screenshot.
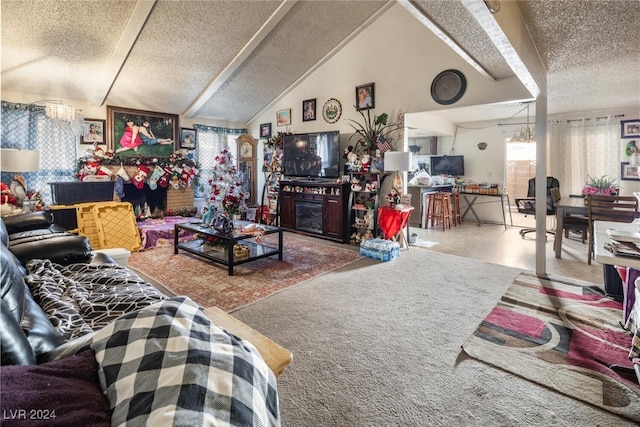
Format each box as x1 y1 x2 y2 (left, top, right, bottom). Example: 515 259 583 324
228 247 640 427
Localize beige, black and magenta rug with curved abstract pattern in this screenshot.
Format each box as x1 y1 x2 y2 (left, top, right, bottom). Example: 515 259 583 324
463 272 640 422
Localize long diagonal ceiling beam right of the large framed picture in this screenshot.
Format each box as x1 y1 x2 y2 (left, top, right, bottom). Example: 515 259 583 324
182 0 298 117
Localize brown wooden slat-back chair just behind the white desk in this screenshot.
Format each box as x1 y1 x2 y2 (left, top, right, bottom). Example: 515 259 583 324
586 194 638 264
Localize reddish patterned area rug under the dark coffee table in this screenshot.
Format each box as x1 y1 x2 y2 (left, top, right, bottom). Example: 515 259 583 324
129 234 363 312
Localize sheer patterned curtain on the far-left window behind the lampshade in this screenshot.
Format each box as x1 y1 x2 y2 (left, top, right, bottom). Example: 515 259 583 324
1 101 79 204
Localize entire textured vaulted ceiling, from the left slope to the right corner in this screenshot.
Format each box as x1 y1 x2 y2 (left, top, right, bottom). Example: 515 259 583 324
1 0 640 122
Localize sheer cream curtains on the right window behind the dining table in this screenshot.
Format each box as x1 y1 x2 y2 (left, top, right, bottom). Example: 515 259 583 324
547 116 621 196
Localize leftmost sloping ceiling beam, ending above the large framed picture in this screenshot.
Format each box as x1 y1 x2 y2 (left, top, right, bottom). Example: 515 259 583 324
94 0 156 106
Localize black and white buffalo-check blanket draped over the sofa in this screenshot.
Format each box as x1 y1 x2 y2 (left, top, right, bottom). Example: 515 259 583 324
90 297 280 426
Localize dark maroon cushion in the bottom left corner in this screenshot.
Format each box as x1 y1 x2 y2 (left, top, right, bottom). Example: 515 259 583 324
0 350 111 427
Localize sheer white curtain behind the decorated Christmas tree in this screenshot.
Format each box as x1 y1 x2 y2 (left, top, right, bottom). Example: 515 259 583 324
193 124 247 199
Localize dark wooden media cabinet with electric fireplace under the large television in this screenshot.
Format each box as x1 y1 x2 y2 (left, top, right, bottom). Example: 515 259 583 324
279 179 349 243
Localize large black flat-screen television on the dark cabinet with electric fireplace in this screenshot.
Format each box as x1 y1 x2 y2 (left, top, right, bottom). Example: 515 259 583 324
282 131 340 178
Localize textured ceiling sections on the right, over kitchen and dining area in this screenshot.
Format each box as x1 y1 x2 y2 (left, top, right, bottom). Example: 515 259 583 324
413 0 640 122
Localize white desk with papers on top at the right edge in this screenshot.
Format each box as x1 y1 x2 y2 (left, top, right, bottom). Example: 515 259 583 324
593 221 640 382
